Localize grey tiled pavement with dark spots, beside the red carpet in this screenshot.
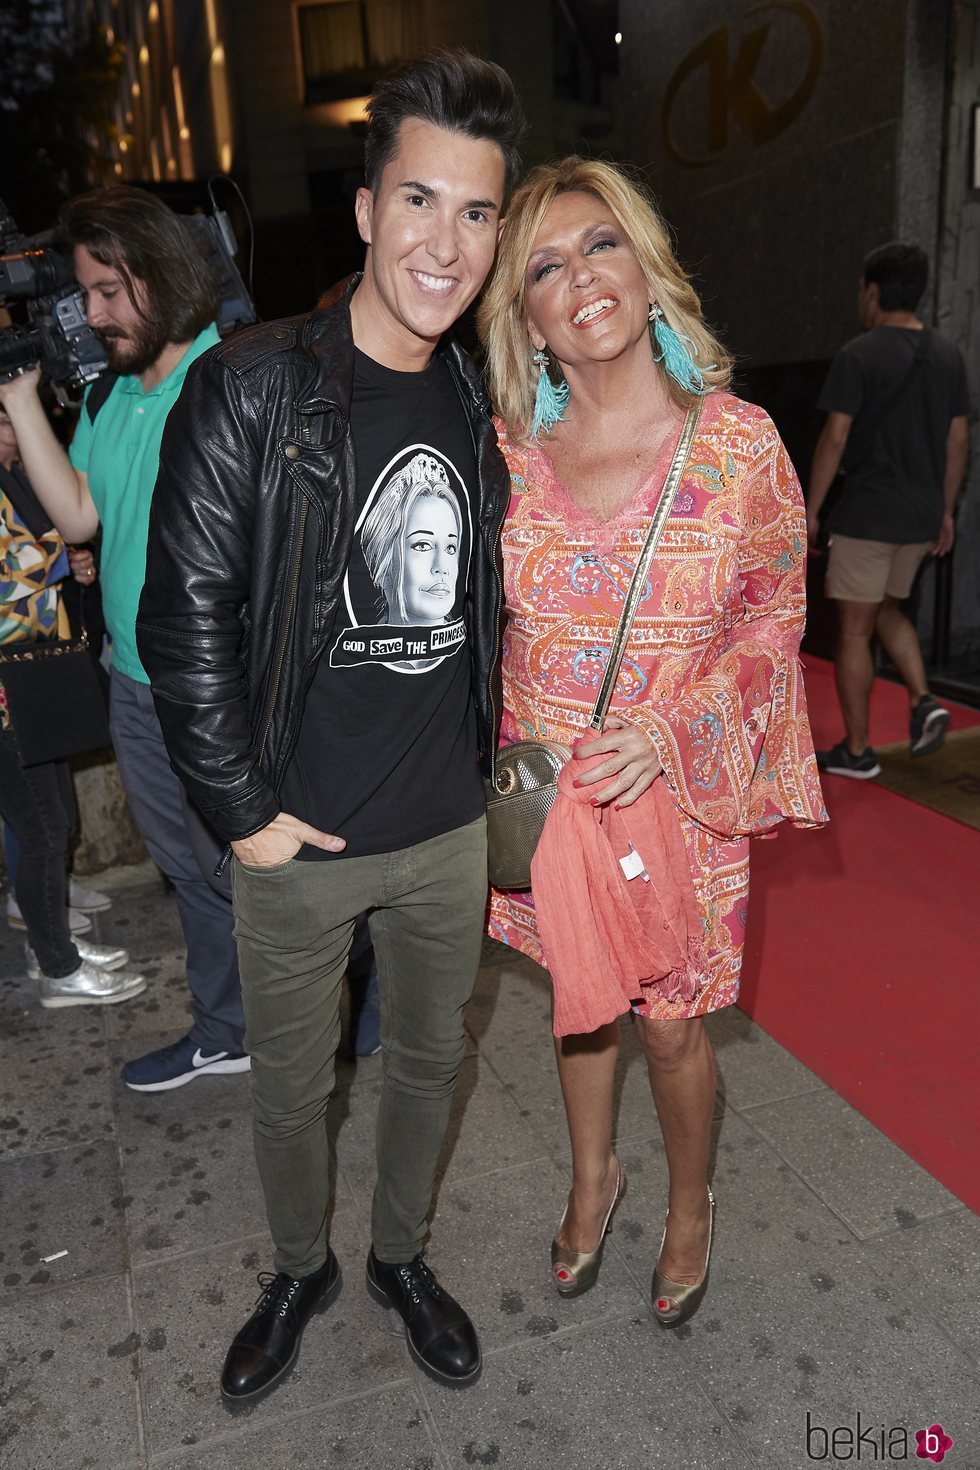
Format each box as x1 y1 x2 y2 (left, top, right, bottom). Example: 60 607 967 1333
0 869 980 1470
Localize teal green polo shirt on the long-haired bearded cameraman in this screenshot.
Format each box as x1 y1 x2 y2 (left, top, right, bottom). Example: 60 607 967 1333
69 323 220 684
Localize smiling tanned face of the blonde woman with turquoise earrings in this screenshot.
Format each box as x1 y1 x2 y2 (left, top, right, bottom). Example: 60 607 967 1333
525 193 651 366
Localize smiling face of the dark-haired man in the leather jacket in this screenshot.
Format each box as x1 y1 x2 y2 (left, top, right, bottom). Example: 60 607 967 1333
354 118 504 368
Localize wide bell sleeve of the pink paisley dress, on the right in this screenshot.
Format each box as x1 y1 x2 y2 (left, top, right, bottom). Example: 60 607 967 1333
637 423 827 838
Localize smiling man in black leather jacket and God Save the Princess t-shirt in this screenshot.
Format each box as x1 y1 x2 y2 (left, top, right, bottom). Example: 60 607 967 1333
138 51 523 1408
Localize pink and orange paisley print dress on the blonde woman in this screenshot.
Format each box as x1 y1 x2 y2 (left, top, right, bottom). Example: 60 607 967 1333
489 392 827 1019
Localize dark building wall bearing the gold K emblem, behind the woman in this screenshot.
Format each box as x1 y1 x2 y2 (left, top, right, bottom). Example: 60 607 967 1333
620 0 980 686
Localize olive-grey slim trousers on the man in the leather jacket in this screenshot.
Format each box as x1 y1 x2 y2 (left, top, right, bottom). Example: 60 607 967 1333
232 817 486 1276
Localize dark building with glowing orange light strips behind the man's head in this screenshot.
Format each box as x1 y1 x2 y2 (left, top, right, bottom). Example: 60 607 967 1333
69 0 619 316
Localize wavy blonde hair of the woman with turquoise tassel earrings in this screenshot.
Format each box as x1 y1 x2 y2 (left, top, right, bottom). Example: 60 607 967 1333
476 154 732 442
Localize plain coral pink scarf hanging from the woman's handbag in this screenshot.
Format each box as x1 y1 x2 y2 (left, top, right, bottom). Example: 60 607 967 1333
530 735 705 1036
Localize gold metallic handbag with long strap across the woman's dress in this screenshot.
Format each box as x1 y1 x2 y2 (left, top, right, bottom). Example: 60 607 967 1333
486 398 702 889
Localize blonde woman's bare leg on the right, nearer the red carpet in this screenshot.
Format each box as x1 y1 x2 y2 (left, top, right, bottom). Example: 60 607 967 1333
636 1016 716 1285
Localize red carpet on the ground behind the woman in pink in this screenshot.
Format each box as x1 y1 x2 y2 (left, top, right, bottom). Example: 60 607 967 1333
739 657 980 1213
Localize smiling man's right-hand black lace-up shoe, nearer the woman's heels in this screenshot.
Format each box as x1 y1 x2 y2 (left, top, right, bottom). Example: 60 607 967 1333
367 1248 483 1388
